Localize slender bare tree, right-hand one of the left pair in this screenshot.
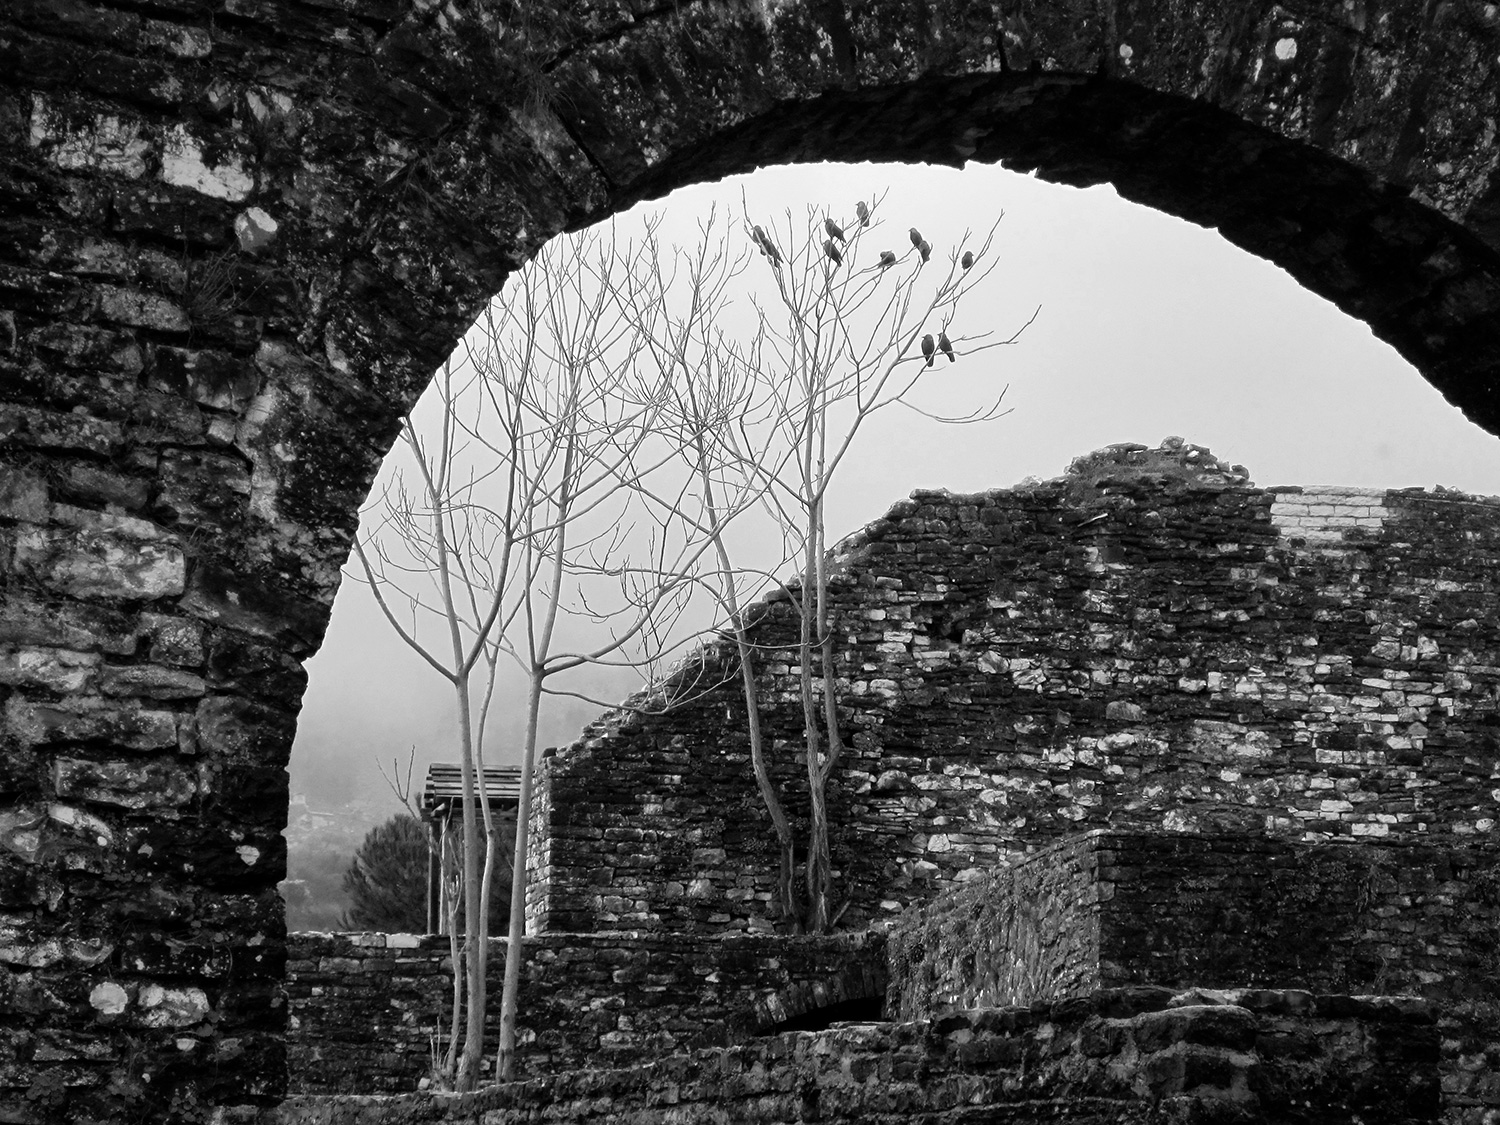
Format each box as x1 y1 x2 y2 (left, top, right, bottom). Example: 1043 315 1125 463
456 222 738 1080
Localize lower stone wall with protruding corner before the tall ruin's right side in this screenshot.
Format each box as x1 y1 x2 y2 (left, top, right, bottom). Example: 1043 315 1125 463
888 830 1500 1019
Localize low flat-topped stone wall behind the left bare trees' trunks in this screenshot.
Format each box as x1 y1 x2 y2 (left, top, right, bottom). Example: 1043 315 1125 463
285 933 887 1094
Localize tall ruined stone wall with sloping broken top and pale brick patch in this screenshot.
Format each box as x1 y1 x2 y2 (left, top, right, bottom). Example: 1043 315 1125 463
531 447 1500 932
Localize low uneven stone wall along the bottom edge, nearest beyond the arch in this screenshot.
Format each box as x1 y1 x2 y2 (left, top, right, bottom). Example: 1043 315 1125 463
258 989 1439 1125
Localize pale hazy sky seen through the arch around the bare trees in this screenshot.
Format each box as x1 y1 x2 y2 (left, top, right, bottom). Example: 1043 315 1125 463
291 165 1500 809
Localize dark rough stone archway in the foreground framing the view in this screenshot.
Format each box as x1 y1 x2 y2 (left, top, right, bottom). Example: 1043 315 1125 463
0 0 1500 1121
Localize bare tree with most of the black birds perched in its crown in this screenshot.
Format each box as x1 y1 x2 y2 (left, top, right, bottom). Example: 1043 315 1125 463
750 200 1035 933
